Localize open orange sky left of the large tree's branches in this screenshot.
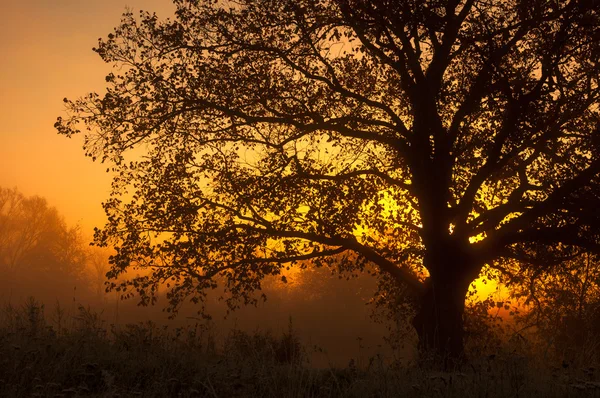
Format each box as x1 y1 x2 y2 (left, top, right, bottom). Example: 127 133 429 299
0 0 174 234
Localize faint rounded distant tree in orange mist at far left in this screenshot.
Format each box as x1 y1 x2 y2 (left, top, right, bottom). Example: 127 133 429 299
0 187 87 298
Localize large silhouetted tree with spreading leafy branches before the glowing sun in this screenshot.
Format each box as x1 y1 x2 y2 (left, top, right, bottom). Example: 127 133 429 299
56 0 600 356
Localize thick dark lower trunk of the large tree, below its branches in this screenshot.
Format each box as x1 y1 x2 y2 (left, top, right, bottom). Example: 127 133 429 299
413 247 480 366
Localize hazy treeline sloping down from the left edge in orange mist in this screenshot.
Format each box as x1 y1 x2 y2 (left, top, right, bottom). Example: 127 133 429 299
0 187 109 301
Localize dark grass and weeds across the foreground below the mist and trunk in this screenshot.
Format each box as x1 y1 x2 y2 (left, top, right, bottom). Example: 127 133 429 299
0 299 600 397
